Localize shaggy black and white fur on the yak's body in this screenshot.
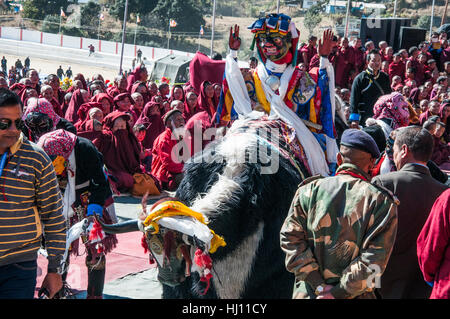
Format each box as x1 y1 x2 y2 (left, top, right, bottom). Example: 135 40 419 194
163 119 302 299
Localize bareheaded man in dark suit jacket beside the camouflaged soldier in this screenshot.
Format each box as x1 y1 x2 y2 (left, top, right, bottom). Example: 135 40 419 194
372 126 447 299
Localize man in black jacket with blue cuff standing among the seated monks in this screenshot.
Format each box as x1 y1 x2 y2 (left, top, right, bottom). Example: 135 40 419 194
350 50 392 125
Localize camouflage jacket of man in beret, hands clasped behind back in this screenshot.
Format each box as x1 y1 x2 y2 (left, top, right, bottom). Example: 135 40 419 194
281 164 399 299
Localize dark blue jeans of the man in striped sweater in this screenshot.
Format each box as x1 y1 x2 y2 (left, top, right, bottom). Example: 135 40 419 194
0 260 37 299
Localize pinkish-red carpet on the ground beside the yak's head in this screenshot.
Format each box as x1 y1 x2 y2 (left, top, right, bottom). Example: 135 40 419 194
36 232 155 297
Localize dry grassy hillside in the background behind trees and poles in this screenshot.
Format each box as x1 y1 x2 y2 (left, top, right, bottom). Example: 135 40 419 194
0 0 445 59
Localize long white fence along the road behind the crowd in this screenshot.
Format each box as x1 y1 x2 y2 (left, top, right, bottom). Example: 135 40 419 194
0 26 195 60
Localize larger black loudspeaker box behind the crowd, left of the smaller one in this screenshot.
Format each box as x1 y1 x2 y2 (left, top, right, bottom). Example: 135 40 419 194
360 18 411 51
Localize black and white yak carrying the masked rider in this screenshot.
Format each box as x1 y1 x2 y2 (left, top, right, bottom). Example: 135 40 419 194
99 117 309 299
